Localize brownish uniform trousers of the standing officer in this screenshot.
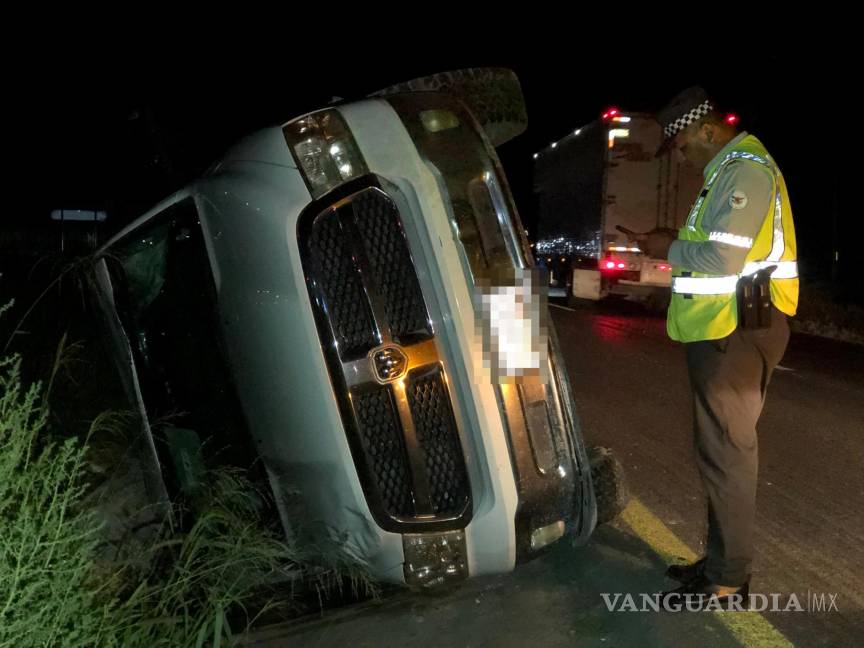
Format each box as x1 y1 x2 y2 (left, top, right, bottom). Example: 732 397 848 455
685 307 789 586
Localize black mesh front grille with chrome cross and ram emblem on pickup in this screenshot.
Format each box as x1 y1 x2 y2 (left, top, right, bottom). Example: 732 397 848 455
298 187 471 531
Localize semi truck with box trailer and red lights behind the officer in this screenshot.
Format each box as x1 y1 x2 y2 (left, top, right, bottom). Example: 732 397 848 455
533 108 703 308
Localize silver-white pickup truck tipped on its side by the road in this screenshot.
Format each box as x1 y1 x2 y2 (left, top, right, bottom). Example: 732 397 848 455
97 70 616 586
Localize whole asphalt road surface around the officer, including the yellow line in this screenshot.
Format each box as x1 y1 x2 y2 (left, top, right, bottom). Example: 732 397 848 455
254 303 864 646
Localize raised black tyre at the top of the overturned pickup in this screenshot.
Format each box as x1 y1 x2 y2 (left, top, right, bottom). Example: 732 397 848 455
369 68 528 146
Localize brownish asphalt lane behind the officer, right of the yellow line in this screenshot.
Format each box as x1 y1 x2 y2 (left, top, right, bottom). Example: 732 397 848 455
553 302 864 645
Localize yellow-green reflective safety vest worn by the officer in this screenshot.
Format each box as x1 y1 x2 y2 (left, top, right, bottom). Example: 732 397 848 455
666 135 798 342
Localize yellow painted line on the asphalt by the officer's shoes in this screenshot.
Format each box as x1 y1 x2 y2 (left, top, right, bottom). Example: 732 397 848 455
620 497 794 648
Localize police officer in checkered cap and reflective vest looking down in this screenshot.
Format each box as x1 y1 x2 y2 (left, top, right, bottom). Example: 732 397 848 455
638 87 798 602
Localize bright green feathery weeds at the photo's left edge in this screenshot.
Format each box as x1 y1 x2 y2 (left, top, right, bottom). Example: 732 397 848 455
0 356 107 647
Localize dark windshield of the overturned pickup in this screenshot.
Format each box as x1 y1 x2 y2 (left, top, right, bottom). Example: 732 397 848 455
109 199 255 489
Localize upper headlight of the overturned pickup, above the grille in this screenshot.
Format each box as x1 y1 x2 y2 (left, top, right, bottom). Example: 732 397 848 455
282 110 369 198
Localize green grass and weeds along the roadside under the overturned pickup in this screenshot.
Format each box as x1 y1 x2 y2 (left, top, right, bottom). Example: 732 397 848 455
0 294 378 648
